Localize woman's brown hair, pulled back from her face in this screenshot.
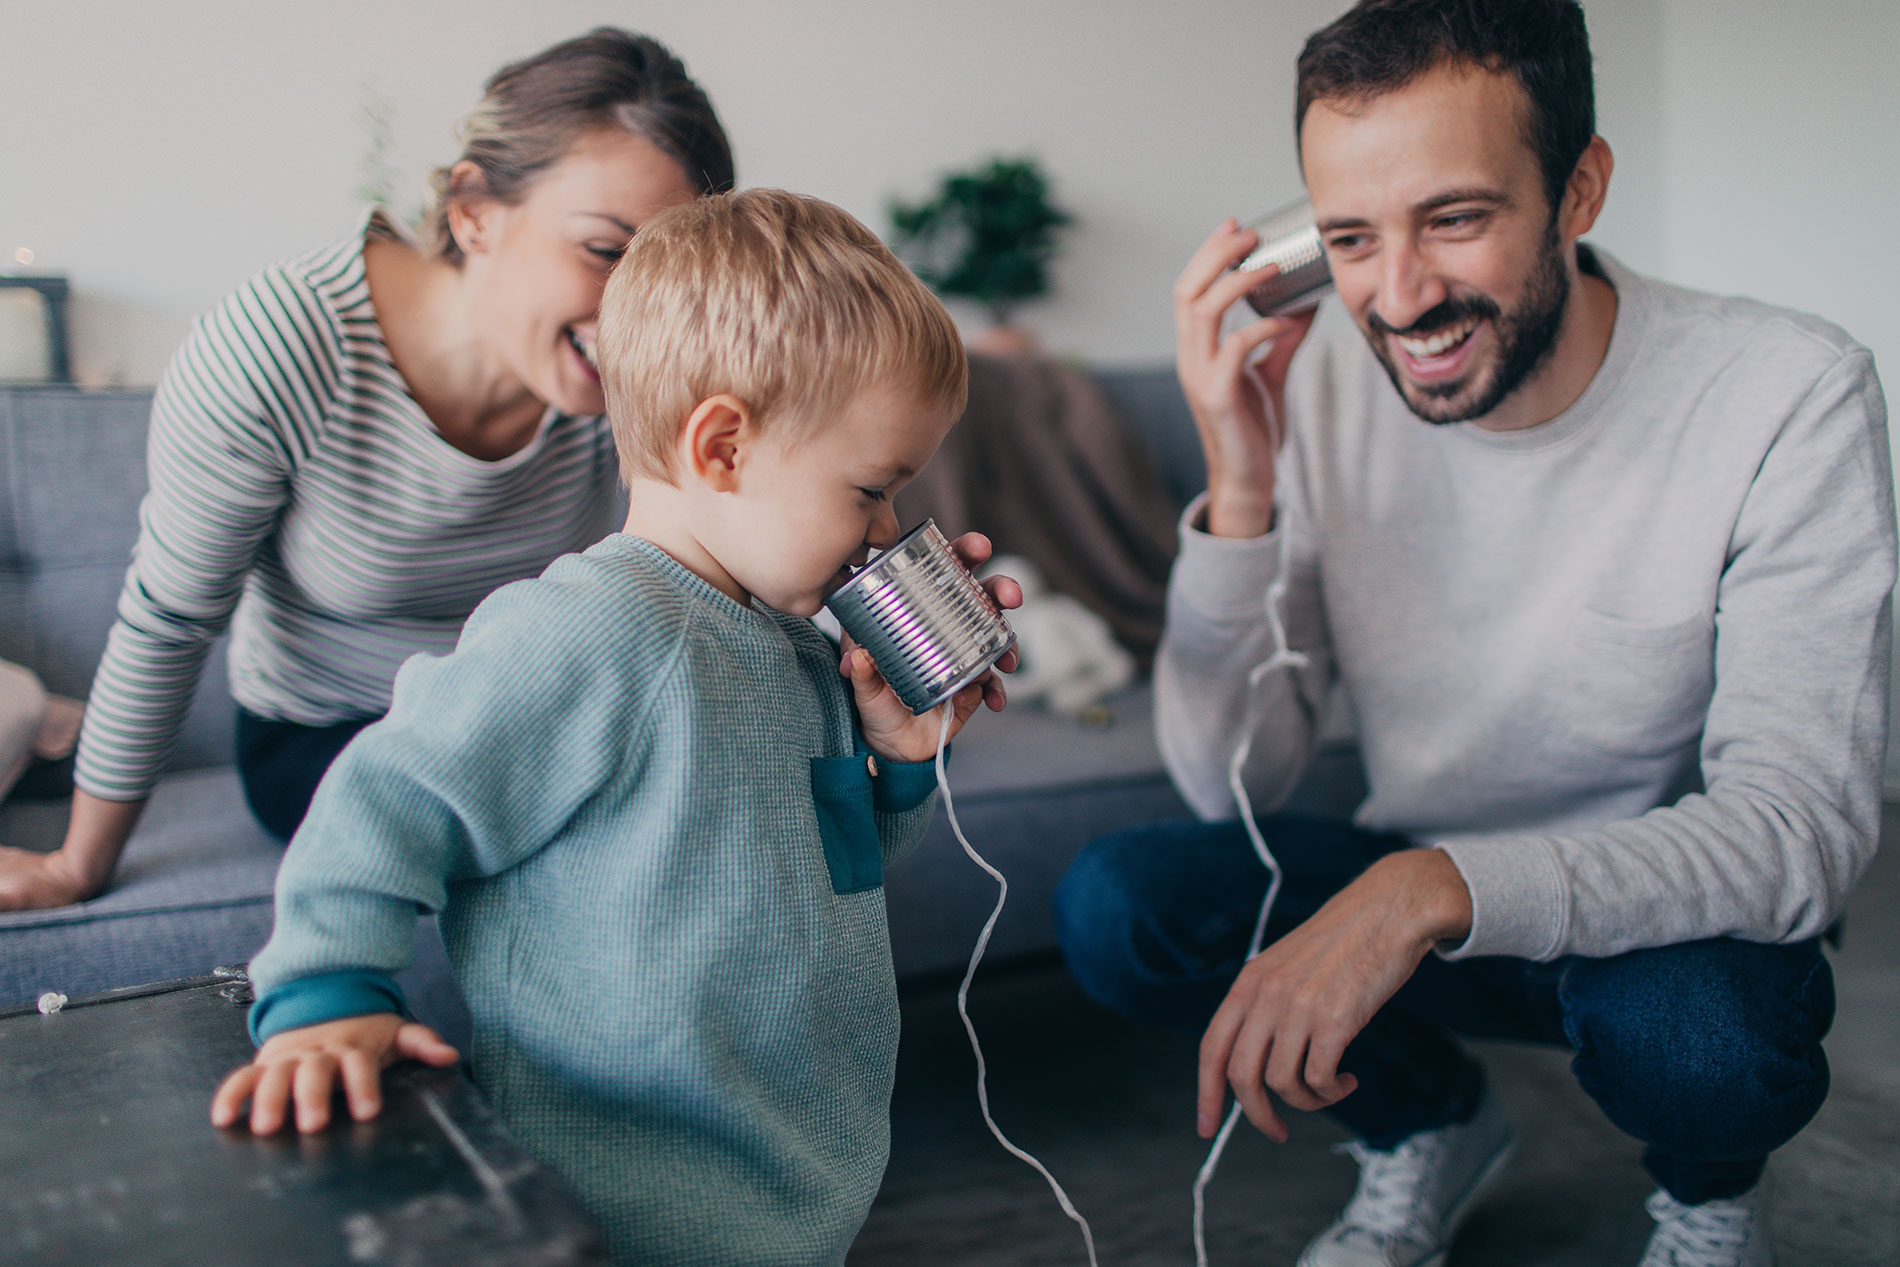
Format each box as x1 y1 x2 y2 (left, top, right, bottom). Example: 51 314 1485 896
424 27 733 264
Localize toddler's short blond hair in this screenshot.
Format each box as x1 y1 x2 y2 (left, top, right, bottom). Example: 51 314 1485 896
597 190 969 481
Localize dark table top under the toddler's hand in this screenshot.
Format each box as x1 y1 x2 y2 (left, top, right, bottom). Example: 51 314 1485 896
0 973 610 1267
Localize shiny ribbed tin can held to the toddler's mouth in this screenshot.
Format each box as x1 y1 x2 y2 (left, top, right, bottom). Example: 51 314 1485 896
825 519 1017 712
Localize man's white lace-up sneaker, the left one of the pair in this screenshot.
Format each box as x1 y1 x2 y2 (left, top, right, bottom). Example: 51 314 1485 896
1300 1090 1514 1267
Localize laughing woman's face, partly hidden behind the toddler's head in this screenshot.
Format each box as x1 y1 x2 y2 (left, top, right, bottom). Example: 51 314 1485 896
456 129 699 414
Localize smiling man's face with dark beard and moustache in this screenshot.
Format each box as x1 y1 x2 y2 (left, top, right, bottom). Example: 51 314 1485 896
1300 66 1571 424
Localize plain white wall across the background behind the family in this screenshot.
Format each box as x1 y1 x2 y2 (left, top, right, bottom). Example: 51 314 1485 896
0 0 1900 767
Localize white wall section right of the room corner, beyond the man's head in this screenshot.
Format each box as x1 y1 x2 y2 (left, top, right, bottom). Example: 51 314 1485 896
1659 0 1900 796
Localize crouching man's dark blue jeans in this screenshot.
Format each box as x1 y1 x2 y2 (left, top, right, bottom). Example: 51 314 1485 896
1056 815 1834 1204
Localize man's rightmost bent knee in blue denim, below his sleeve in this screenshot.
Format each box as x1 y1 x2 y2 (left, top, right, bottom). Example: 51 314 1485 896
1564 938 1834 1161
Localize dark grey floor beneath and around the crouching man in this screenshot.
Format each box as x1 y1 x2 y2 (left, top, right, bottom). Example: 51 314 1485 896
849 805 1900 1267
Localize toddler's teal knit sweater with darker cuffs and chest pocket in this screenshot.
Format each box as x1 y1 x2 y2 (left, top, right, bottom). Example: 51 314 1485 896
251 536 935 1267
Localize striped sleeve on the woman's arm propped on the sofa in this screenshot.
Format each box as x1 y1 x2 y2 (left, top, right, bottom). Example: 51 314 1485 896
74 268 338 800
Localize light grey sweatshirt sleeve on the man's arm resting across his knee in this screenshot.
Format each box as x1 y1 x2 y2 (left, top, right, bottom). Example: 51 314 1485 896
1442 348 1896 959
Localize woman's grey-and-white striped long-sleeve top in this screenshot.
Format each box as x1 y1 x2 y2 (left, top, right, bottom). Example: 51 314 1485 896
76 215 616 800
